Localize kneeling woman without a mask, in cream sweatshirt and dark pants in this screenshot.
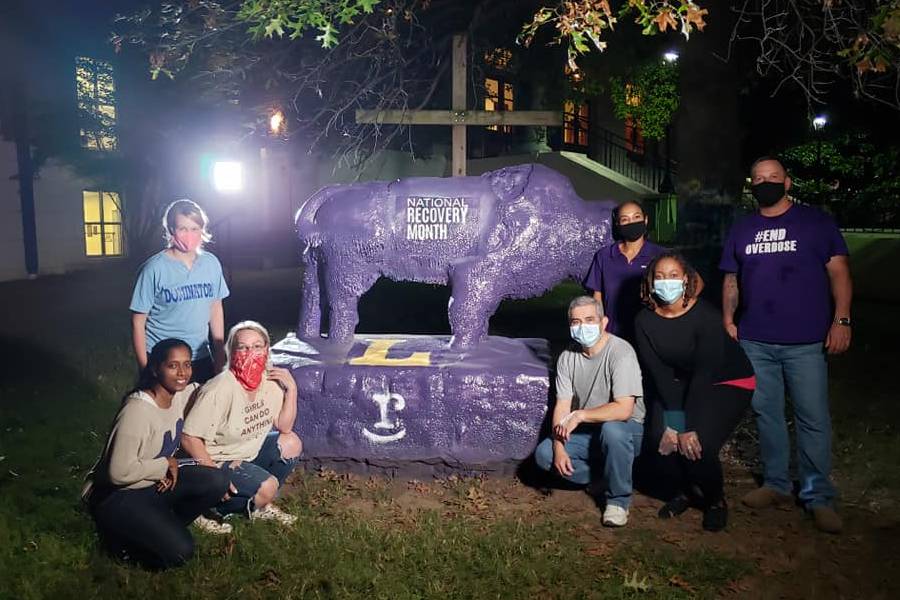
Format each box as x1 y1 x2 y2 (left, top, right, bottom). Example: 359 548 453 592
85 339 229 569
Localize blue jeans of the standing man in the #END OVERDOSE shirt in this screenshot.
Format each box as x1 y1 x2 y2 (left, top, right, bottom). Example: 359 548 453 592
741 340 835 508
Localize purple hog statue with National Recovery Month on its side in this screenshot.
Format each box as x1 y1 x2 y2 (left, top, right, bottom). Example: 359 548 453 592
296 164 612 349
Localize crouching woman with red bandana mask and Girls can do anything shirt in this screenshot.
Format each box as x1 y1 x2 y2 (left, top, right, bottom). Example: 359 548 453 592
181 321 302 529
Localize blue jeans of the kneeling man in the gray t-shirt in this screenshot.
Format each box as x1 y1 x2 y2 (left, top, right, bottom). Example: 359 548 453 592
534 420 644 508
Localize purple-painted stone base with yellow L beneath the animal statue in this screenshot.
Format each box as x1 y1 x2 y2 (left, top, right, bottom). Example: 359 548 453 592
272 335 549 473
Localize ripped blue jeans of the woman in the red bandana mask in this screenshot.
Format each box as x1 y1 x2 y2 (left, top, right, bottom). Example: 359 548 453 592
216 431 300 517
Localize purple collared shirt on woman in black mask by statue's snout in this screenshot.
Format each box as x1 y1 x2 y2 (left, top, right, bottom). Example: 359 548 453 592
584 240 665 341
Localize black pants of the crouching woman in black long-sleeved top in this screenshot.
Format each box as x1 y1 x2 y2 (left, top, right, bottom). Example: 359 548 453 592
645 385 753 507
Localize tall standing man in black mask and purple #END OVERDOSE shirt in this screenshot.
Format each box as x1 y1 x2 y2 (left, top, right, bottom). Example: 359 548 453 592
719 157 852 533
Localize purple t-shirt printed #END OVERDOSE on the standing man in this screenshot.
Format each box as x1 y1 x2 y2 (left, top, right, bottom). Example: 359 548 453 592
719 204 849 344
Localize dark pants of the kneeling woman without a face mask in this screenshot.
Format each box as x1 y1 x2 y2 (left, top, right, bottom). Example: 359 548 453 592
91 465 228 569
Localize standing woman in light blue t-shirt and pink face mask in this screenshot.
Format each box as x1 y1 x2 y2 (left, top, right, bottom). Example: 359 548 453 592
129 200 229 383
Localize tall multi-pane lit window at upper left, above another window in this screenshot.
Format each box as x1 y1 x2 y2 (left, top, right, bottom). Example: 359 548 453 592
75 56 118 150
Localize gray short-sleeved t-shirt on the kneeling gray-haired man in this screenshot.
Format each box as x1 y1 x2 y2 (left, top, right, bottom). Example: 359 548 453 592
556 334 647 423
